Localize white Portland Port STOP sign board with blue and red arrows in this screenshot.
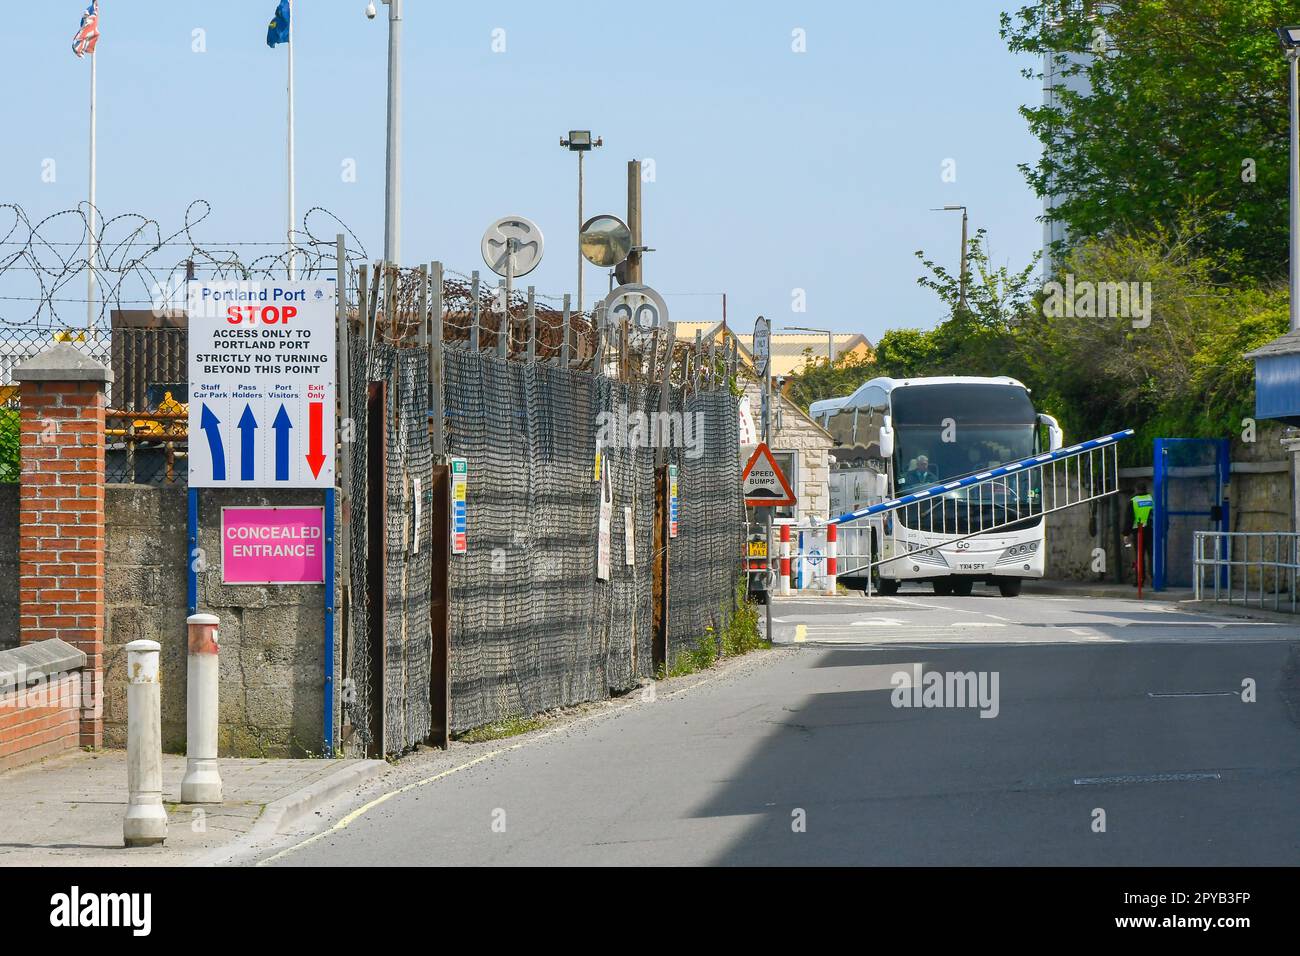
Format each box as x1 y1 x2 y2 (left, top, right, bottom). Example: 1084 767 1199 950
189 280 335 488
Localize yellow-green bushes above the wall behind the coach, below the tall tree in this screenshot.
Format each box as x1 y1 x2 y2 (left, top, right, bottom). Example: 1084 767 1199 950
796 222 1287 463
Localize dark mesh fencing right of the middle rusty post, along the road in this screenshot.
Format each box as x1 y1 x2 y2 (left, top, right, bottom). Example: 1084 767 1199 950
443 346 742 732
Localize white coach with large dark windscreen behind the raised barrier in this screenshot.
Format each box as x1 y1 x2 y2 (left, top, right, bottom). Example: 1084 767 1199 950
810 376 1061 597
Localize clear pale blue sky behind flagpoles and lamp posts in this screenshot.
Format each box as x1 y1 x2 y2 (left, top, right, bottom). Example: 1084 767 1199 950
0 0 1041 339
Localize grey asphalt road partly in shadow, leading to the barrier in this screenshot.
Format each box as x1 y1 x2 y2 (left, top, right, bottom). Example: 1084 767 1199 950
256 592 1300 865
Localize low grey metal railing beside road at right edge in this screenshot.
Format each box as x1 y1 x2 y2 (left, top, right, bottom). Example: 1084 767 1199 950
1192 531 1300 614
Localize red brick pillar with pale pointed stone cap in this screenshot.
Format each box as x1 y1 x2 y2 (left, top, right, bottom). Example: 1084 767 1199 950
13 342 113 747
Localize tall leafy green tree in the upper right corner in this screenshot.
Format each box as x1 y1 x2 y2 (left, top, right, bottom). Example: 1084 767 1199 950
1001 0 1300 280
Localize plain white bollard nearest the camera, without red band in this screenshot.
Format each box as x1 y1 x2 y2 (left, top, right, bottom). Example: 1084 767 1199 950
122 640 166 847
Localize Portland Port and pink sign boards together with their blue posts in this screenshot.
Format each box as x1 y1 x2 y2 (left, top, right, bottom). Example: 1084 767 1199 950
187 280 338 754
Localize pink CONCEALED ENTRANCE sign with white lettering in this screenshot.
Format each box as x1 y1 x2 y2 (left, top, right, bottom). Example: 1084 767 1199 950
221 506 325 584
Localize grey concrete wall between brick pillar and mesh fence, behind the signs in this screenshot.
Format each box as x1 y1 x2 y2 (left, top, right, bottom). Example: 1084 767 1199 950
104 485 341 757
